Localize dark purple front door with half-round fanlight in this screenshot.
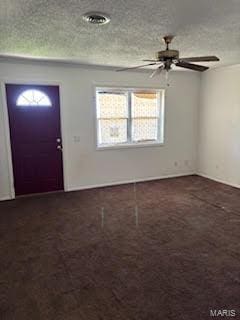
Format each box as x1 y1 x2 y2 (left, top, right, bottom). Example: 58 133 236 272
6 84 63 195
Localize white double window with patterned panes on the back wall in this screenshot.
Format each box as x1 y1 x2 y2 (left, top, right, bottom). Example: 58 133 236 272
96 88 164 148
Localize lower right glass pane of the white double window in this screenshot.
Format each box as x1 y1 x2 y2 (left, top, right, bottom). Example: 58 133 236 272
132 118 158 142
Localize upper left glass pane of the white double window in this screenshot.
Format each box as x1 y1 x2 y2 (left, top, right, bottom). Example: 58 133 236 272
97 92 128 118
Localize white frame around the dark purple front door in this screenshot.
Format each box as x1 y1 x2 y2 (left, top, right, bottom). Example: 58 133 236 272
0 78 68 199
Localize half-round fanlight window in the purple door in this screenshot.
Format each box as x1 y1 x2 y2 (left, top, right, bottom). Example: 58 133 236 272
16 89 52 107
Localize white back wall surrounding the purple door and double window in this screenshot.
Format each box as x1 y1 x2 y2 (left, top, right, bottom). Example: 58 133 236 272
0 62 200 198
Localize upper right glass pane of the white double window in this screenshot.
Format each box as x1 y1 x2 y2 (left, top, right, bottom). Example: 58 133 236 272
131 92 159 118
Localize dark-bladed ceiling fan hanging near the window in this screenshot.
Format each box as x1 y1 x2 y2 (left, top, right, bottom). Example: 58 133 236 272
116 35 219 78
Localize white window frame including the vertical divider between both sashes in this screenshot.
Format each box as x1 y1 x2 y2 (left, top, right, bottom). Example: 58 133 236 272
94 85 165 150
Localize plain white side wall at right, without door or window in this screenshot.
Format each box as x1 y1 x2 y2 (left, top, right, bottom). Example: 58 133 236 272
198 65 240 186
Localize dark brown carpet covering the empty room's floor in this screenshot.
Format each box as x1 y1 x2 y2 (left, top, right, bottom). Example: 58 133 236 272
0 176 240 320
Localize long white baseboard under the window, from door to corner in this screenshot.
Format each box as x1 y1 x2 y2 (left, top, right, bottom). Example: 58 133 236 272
66 171 196 191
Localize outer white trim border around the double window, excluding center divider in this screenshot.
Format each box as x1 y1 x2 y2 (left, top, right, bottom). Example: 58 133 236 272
94 85 165 151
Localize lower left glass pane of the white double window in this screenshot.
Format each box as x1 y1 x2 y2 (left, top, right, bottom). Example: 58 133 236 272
99 119 127 144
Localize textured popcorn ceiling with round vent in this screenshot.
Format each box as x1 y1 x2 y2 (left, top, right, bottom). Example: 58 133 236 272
0 0 240 66
